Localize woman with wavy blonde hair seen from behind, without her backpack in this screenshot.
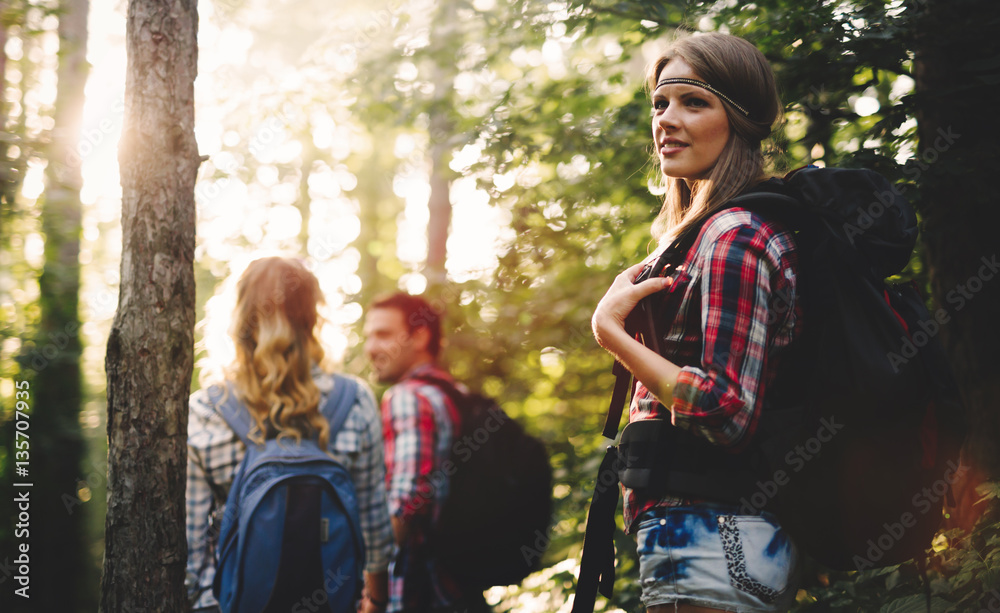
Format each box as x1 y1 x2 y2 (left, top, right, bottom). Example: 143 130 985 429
186 257 392 612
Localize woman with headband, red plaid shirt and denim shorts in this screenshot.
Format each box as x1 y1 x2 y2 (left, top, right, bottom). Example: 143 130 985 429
592 34 802 613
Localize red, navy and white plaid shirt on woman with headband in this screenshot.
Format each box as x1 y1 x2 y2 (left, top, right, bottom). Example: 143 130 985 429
623 208 801 531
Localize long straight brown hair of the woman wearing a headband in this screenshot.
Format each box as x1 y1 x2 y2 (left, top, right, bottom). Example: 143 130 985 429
646 33 782 240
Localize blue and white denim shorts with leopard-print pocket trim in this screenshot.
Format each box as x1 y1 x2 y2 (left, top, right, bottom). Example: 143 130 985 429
636 504 798 613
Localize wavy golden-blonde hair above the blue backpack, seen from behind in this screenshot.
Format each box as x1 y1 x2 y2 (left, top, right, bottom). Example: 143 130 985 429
226 257 330 449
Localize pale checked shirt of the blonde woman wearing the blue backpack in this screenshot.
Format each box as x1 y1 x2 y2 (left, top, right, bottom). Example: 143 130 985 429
185 370 392 609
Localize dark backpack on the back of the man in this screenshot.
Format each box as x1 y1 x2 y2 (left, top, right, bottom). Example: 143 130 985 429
415 376 552 591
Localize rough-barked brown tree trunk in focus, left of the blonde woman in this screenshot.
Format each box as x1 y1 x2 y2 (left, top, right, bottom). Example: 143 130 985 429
101 0 199 613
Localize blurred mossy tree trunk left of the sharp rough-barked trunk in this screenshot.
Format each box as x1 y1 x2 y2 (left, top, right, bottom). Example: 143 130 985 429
28 0 90 611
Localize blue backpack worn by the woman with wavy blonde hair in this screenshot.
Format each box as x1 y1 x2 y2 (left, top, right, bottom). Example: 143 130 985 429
209 376 365 613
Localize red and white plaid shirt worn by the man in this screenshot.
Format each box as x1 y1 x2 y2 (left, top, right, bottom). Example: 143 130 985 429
382 364 461 613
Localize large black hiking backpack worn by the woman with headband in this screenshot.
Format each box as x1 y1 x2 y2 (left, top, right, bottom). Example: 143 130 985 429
573 168 966 613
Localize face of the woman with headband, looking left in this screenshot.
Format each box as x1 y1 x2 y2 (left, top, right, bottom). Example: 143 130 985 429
652 57 730 181
